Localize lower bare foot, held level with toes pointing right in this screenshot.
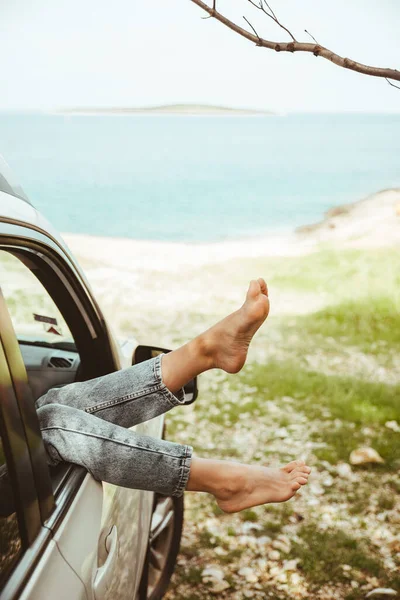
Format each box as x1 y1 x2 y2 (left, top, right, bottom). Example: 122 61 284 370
213 460 311 513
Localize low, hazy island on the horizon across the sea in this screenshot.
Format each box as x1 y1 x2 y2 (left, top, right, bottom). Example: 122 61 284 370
57 104 276 116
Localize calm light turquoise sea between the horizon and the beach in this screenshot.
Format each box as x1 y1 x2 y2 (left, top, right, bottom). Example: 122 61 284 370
0 113 400 242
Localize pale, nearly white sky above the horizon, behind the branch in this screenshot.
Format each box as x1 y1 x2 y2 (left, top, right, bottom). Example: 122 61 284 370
0 0 400 112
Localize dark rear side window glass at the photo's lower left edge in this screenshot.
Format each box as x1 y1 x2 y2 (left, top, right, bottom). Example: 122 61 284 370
0 435 21 584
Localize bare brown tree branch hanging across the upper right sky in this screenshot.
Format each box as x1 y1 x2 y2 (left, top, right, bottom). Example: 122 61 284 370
191 0 400 87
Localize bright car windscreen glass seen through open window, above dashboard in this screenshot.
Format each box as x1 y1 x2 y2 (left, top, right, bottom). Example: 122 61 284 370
0 250 73 346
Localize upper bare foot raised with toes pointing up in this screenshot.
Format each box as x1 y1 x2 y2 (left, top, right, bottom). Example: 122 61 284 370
200 277 269 373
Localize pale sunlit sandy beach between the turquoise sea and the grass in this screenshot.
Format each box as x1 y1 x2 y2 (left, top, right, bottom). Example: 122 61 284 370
64 190 400 343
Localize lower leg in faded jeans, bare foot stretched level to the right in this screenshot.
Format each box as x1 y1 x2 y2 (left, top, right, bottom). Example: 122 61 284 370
38 404 310 512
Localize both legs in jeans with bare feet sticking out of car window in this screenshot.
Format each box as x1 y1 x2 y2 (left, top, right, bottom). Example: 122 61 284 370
37 279 310 512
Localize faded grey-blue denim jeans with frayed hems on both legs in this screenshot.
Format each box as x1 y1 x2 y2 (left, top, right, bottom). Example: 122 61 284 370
36 355 193 496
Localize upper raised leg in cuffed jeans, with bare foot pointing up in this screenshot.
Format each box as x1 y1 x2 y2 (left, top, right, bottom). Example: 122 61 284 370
36 279 269 427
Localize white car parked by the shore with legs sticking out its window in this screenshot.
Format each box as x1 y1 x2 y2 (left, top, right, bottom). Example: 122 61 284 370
0 158 198 600
